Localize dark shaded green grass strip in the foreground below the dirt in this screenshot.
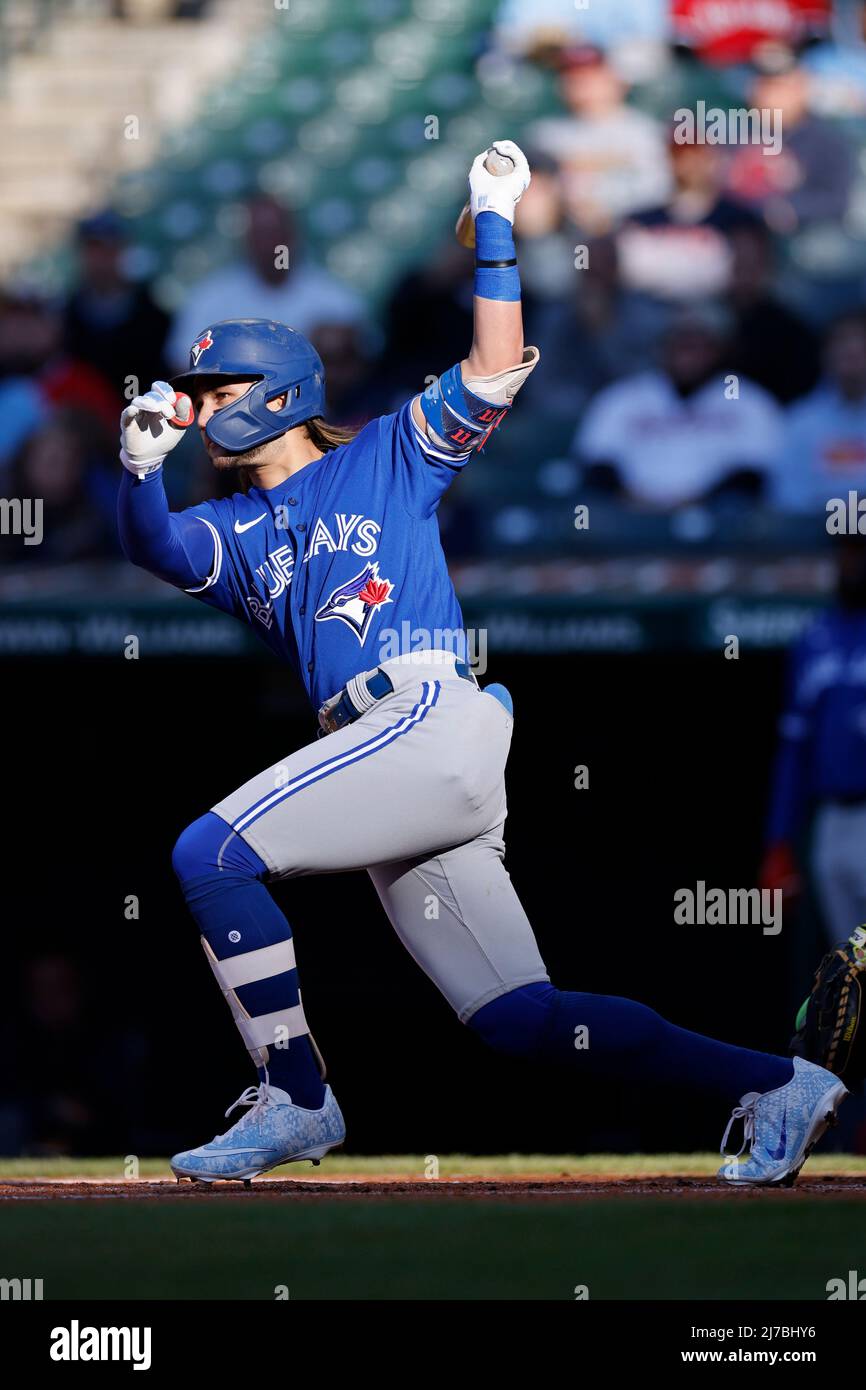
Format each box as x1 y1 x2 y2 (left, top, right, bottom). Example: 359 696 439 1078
0 1194 866 1301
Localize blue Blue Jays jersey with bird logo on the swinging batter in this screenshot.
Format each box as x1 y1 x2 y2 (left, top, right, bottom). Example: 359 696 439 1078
174 402 470 708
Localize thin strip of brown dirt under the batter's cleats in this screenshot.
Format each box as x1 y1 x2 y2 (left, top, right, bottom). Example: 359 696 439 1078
0 1173 866 1202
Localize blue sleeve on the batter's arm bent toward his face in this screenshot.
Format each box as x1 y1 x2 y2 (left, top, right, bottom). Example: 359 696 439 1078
117 468 214 588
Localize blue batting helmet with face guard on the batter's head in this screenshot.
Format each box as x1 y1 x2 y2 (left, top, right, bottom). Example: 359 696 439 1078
171 318 325 453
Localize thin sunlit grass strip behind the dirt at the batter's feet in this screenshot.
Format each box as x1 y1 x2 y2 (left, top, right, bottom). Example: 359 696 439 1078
0 1154 866 1182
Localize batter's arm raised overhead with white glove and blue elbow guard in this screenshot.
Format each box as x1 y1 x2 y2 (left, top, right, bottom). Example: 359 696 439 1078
413 140 539 452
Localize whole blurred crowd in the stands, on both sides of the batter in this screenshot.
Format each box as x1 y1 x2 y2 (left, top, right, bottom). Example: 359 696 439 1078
0 23 866 563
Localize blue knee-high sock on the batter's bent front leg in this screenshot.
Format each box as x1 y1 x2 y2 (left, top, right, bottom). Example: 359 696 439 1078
172 812 325 1109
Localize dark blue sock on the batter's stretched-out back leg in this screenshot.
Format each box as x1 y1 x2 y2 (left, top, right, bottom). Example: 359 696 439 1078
468 983 794 1105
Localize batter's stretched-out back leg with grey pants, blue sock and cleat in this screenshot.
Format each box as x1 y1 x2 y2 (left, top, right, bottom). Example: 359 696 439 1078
370 831 847 1182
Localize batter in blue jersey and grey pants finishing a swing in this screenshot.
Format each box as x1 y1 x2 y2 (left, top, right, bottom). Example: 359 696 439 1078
120 140 847 1183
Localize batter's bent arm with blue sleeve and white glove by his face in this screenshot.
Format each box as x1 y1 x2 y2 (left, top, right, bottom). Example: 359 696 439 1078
117 381 214 588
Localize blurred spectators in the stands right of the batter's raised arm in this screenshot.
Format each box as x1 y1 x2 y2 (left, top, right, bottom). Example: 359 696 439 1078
518 46 866 514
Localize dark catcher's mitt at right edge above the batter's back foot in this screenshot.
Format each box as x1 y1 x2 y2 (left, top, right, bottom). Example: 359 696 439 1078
791 926 866 1087
